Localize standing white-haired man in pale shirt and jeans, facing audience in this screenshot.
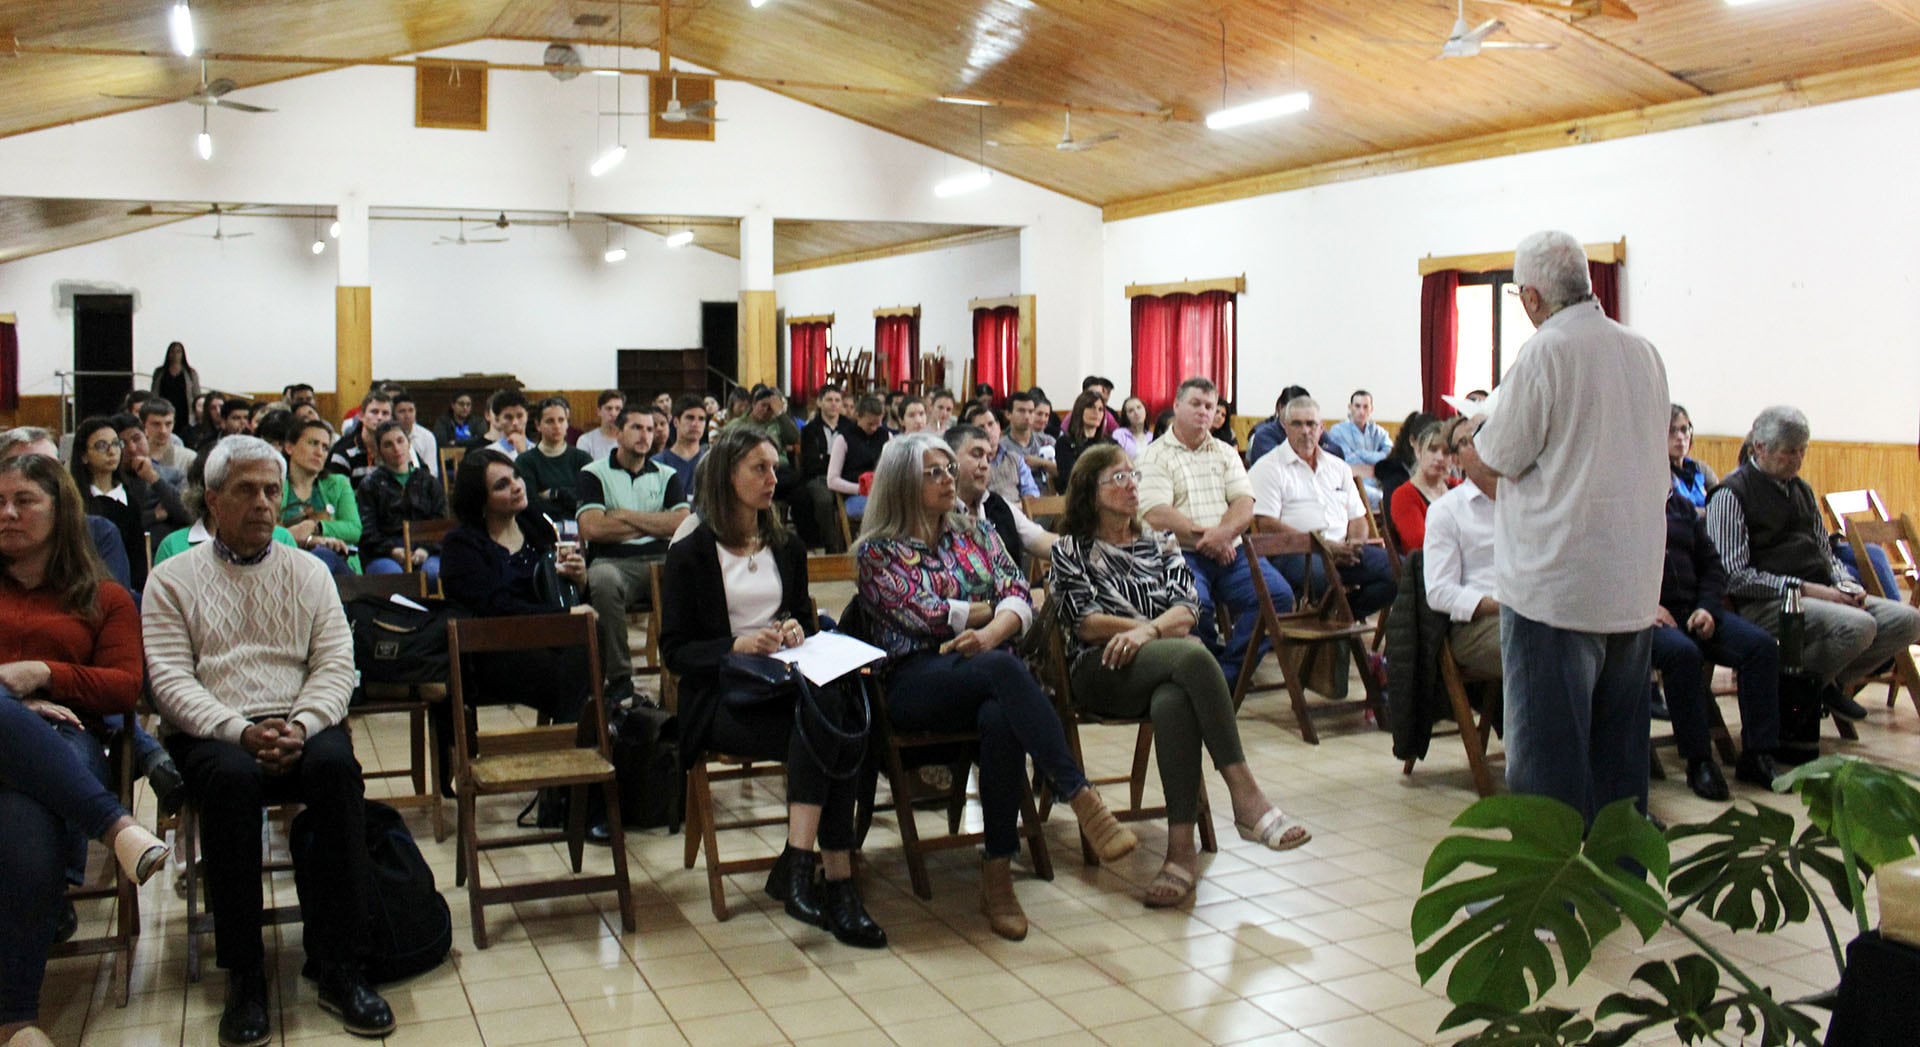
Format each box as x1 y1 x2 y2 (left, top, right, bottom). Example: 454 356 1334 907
1467 232 1668 822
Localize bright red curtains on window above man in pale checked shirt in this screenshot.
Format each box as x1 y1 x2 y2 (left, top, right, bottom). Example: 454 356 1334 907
1133 290 1238 417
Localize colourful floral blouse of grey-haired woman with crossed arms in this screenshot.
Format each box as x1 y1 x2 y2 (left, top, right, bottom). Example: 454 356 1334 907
856 515 1033 657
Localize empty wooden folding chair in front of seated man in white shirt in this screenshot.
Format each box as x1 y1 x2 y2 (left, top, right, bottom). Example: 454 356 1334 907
1233 532 1388 745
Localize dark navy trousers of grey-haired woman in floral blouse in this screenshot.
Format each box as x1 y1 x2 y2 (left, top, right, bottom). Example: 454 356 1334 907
885 649 1087 859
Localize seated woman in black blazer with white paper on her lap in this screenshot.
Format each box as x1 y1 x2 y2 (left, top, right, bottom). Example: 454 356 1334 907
660 428 887 949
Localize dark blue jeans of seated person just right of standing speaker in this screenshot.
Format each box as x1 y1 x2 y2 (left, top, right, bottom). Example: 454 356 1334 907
1653 611 1780 761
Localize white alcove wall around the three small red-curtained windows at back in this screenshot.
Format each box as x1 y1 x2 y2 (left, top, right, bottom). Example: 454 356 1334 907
774 236 1020 393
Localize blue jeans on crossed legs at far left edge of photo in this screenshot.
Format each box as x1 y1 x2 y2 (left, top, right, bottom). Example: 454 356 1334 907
0 688 127 1024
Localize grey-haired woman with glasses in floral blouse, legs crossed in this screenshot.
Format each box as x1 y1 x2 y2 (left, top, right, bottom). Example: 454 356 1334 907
854 434 1139 941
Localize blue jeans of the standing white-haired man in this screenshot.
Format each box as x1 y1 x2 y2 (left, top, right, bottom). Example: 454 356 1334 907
1500 607 1653 824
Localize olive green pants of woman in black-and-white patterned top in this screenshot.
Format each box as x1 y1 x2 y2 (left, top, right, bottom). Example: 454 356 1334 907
1073 640 1246 826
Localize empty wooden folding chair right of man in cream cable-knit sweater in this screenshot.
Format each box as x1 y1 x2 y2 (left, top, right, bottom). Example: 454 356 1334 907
447 615 636 949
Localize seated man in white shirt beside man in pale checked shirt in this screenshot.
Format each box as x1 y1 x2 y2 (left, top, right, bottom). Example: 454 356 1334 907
1246 396 1398 619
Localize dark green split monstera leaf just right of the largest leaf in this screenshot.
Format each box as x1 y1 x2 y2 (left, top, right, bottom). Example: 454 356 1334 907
1667 807 1812 932
